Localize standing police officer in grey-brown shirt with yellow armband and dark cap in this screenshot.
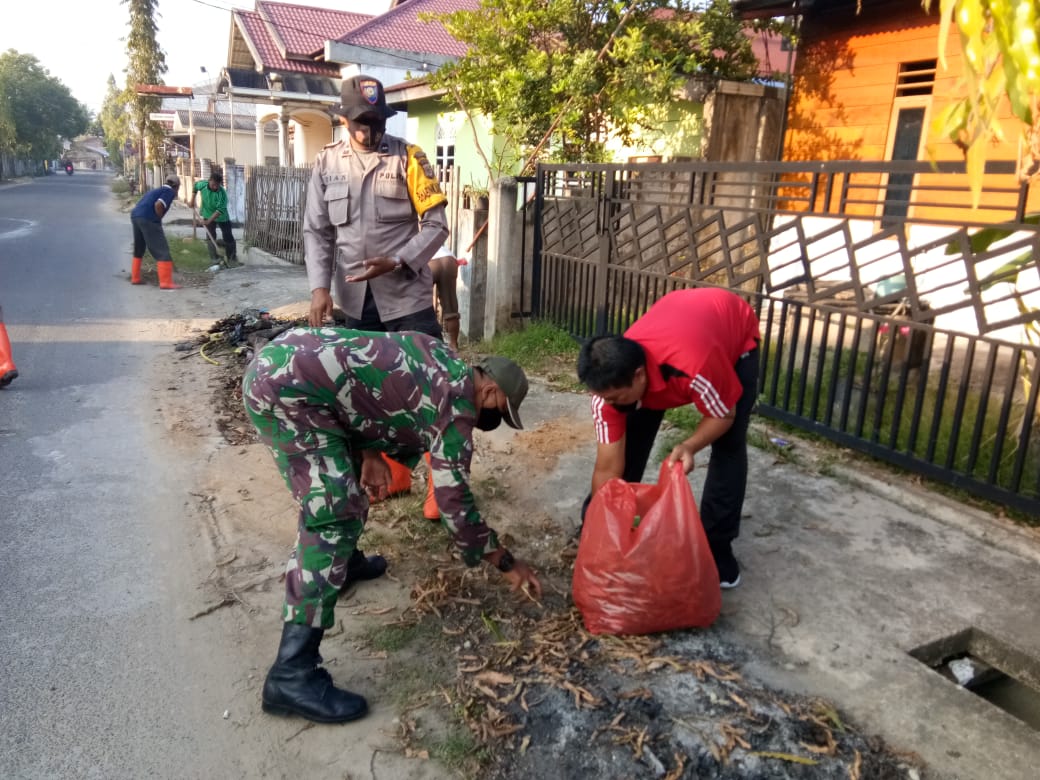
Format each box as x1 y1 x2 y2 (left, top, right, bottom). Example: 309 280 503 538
304 75 448 583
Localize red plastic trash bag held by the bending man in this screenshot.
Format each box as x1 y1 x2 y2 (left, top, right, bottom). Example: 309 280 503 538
572 463 722 634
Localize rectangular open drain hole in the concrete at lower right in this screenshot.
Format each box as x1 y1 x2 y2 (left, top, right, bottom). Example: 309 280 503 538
910 628 1040 731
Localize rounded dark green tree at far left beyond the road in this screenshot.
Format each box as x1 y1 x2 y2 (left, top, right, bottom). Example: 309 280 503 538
0 49 90 169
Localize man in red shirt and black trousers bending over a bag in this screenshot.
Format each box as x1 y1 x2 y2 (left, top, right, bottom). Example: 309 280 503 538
578 287 759 588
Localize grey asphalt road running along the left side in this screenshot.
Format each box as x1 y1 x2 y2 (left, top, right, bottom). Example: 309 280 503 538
0 172 264 778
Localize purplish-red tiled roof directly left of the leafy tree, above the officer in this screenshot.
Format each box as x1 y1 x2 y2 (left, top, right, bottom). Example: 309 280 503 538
338 0 480 57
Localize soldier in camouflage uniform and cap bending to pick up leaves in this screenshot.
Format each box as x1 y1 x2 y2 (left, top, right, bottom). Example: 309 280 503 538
242 326 541 723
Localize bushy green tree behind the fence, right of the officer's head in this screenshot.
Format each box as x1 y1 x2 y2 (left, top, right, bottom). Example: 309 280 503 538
430 0 757 176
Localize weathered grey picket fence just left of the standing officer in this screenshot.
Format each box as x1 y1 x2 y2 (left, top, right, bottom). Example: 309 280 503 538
244 165 311 264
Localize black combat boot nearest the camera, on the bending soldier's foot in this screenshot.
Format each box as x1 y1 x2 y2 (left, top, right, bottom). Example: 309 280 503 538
261 623 368 723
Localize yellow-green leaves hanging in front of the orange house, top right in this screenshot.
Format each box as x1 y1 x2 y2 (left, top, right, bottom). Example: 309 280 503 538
921 0 1040 206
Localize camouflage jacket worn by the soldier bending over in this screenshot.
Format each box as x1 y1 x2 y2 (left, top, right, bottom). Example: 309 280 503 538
251 328 498 566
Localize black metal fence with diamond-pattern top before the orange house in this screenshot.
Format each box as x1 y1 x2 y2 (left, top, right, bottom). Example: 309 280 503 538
531 162 1040 514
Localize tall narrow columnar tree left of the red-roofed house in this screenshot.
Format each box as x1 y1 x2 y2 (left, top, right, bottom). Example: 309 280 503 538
122 0 166 184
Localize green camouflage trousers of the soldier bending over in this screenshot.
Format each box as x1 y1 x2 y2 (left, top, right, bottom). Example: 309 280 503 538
242 363 368 628
